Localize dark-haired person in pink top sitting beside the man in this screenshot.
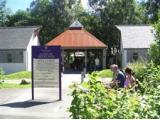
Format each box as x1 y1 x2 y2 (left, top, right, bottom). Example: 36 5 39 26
124 67 135 88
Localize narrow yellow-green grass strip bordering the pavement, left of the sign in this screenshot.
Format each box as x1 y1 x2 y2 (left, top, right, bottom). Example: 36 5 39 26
0 83 31 89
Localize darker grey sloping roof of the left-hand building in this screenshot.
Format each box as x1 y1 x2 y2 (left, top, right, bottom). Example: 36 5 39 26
0 26 39 49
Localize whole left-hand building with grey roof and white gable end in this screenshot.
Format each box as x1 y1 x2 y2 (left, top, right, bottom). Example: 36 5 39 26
0 27 40 74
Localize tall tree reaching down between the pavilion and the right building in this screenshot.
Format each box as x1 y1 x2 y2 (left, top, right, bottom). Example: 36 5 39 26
89 0 143 54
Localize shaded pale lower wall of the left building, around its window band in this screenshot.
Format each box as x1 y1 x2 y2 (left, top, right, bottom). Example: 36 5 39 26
0 51 26 74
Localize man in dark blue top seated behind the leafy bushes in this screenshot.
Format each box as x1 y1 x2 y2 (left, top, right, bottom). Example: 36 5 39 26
110 64 126 88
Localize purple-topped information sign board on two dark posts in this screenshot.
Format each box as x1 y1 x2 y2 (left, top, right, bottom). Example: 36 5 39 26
32 46 62 100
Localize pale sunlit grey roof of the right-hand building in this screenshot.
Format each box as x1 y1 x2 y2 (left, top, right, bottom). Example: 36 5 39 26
117 25 155 49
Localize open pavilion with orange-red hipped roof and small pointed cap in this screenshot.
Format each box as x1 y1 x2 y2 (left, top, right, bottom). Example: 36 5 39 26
46 21 107 71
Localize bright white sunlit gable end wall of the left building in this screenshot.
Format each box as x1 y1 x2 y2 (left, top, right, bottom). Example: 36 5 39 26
26 33 40 71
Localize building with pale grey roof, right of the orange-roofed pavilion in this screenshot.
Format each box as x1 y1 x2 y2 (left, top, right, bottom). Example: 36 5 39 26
117 25 155 67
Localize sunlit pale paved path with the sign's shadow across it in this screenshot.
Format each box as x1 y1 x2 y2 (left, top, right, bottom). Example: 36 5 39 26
0 74 81 119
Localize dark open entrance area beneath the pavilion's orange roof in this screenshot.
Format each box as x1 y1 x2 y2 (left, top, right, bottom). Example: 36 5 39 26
63 49 103 72
